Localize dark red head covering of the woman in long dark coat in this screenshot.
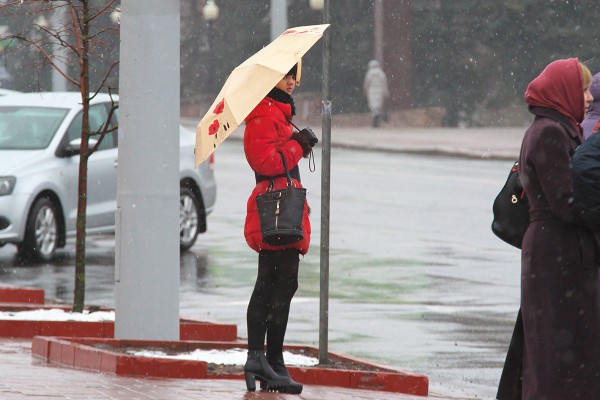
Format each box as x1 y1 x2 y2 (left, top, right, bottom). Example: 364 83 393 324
525 58 584 126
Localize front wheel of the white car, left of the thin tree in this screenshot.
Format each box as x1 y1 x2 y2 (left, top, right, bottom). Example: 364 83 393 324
19 197 59 261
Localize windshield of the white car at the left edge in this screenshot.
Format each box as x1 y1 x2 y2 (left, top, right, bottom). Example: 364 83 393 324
0 106 69 150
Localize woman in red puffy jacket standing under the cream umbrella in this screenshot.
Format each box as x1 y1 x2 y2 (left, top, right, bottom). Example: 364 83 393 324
244 67 314 394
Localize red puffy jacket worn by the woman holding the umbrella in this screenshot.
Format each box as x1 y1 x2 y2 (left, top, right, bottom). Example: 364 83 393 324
244 97 310 254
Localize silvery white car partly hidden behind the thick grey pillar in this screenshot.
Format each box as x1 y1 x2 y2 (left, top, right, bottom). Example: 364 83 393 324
0 92 216 261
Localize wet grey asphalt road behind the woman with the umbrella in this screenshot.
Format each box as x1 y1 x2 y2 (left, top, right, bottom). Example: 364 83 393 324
0 140 519 399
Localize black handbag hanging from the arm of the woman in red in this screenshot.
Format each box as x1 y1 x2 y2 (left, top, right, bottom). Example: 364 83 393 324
256 153 306 246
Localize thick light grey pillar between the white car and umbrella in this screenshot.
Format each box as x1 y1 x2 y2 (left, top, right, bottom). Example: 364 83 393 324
115 0 180 340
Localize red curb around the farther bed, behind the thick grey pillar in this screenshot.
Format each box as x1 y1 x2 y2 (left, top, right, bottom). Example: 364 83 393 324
0 304 237 341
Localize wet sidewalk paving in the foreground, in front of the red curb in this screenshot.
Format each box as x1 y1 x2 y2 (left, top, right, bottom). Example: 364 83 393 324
0 339 448 400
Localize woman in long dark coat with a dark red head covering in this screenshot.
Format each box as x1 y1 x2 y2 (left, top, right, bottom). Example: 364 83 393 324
497 58 600 400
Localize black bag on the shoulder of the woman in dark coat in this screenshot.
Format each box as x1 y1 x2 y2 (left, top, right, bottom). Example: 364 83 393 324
492 162 529 249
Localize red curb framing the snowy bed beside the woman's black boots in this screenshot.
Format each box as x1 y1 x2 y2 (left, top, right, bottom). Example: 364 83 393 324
31 336 429 396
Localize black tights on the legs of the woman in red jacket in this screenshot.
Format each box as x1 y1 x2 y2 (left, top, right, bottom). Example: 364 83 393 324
246 249 300 356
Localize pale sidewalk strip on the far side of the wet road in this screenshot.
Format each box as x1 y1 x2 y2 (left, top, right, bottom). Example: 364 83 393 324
181 118 527 160
